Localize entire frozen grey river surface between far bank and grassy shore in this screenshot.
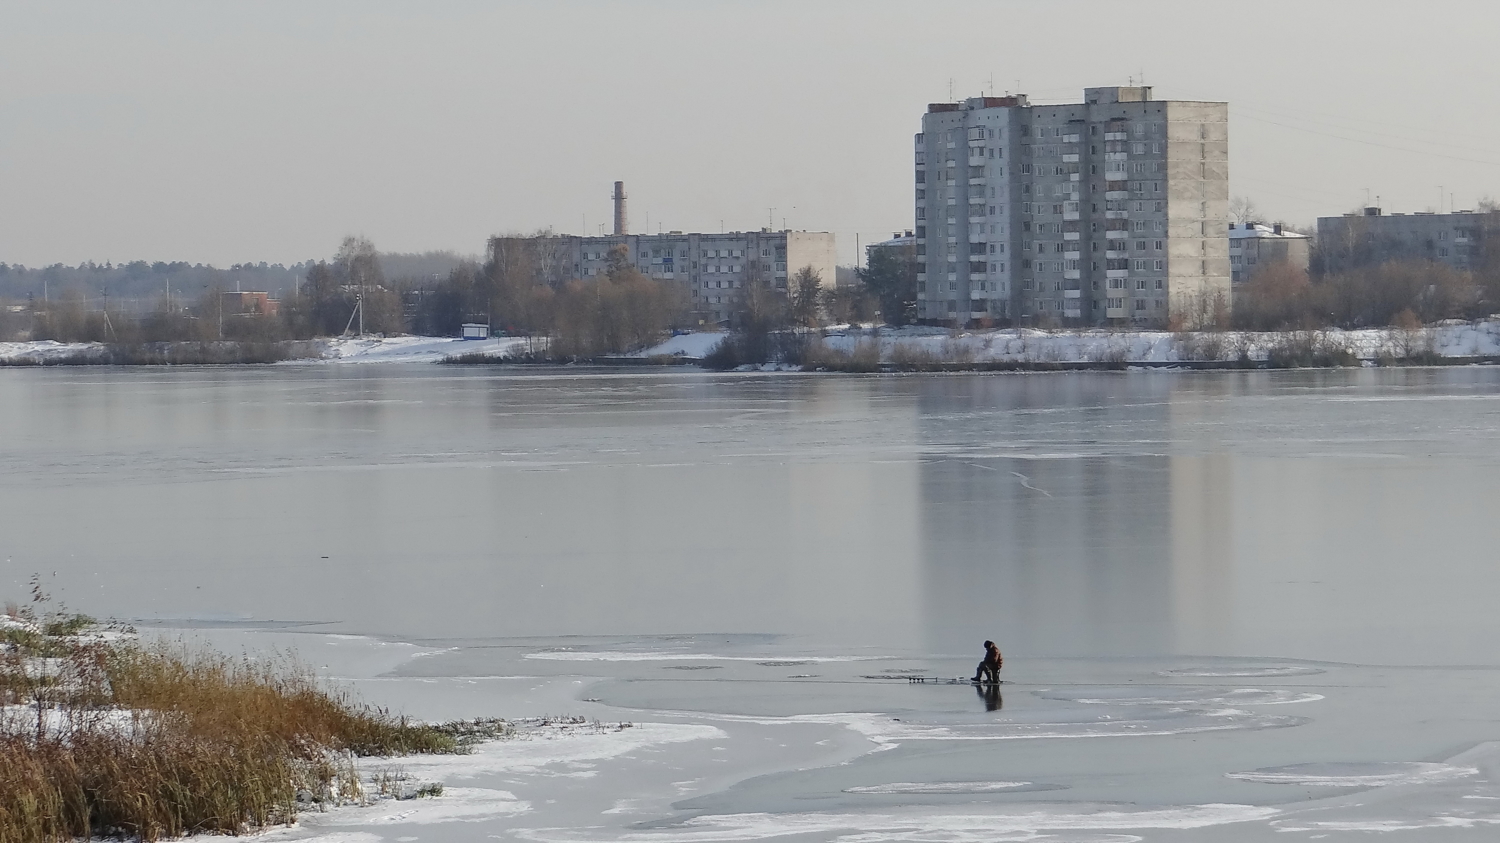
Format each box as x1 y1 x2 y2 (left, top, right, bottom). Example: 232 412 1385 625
0 365 1500 843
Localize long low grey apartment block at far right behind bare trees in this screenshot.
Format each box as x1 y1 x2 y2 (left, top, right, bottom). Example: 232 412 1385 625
1317 207 1500 273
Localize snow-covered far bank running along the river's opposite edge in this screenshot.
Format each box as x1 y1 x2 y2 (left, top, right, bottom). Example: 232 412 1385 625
0 320 1500 374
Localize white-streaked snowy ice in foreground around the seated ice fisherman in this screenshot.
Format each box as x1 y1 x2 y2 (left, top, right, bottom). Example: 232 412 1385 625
141 632 1500 843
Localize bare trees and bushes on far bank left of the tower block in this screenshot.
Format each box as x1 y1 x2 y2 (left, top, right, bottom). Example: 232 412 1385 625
0 233 873 359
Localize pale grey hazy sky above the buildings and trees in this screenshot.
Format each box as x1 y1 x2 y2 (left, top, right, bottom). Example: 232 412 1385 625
0 0 1500 266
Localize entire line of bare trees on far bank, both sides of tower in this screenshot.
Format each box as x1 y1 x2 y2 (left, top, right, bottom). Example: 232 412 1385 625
11 215 1500 348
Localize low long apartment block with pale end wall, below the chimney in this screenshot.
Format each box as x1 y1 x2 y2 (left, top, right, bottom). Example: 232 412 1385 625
560 228 839 326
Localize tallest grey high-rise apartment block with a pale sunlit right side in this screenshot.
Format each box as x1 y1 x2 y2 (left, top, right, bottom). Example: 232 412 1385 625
917 87 1230 326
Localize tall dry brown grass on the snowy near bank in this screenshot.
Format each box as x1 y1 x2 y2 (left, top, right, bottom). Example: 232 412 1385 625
0 594 507 843
